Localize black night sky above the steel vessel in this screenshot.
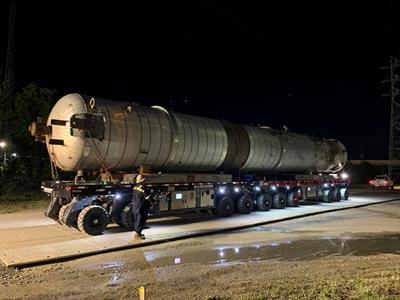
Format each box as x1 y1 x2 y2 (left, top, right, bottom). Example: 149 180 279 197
0 0 400 159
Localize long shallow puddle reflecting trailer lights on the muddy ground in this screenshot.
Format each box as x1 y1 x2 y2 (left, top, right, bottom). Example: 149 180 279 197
144 235 400 267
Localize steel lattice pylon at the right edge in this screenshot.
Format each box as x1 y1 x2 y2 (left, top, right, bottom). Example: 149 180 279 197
381 56 400 178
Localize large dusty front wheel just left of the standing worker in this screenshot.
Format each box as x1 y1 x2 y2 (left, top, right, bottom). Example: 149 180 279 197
77 205 108 235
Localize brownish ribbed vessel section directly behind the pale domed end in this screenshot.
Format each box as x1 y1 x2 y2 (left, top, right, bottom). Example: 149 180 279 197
86 98 172 170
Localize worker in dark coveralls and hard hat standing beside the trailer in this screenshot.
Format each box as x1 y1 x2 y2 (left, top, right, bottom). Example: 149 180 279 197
132 174 150 240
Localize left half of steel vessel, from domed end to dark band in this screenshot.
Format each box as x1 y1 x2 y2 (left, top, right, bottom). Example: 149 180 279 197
48 94 228 171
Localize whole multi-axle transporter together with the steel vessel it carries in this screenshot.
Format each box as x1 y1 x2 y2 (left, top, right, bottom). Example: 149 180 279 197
30 94 349 234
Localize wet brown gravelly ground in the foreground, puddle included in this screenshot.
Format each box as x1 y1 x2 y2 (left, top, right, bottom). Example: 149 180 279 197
0 191 400 299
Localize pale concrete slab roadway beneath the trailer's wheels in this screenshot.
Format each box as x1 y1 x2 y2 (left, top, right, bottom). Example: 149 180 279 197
0 191 400 267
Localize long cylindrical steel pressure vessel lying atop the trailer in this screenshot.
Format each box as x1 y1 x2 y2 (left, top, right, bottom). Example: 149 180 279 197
31 94 347 173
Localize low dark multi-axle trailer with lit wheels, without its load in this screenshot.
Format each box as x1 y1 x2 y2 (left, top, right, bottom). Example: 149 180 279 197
42 174 349 235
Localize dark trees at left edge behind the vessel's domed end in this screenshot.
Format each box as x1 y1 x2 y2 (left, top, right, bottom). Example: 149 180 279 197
0 82 56 199
